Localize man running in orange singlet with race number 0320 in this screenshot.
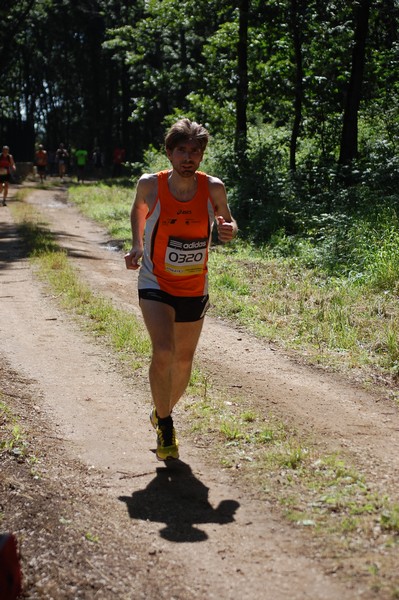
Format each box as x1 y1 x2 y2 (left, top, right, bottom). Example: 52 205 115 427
125 119 237 460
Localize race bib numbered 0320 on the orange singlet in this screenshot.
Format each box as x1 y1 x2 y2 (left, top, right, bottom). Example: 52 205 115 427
165 237 208 277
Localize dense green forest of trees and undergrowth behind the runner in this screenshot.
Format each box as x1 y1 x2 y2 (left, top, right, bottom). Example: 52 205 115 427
0 0 399 253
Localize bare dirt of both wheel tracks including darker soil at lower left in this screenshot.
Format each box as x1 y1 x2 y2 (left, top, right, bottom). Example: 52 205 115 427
0 188 399 600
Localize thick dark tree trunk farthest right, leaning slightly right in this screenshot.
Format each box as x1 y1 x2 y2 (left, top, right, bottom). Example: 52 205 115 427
339 0 371 165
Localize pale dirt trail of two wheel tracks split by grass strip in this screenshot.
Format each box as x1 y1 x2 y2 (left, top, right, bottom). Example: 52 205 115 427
0 185 399 600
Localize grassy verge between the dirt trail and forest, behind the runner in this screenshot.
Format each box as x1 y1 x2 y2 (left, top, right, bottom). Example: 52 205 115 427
70 185 399 383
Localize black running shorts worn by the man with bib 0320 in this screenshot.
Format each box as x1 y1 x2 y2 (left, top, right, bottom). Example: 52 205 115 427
139 289 209 323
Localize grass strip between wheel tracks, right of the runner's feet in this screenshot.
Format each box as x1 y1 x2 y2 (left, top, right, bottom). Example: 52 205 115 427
183 393 399 551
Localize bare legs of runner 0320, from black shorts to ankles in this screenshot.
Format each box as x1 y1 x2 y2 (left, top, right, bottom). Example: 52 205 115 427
140 300 203 418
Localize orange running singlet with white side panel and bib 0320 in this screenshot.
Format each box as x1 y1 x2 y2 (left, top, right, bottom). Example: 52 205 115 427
138 171 215 296
